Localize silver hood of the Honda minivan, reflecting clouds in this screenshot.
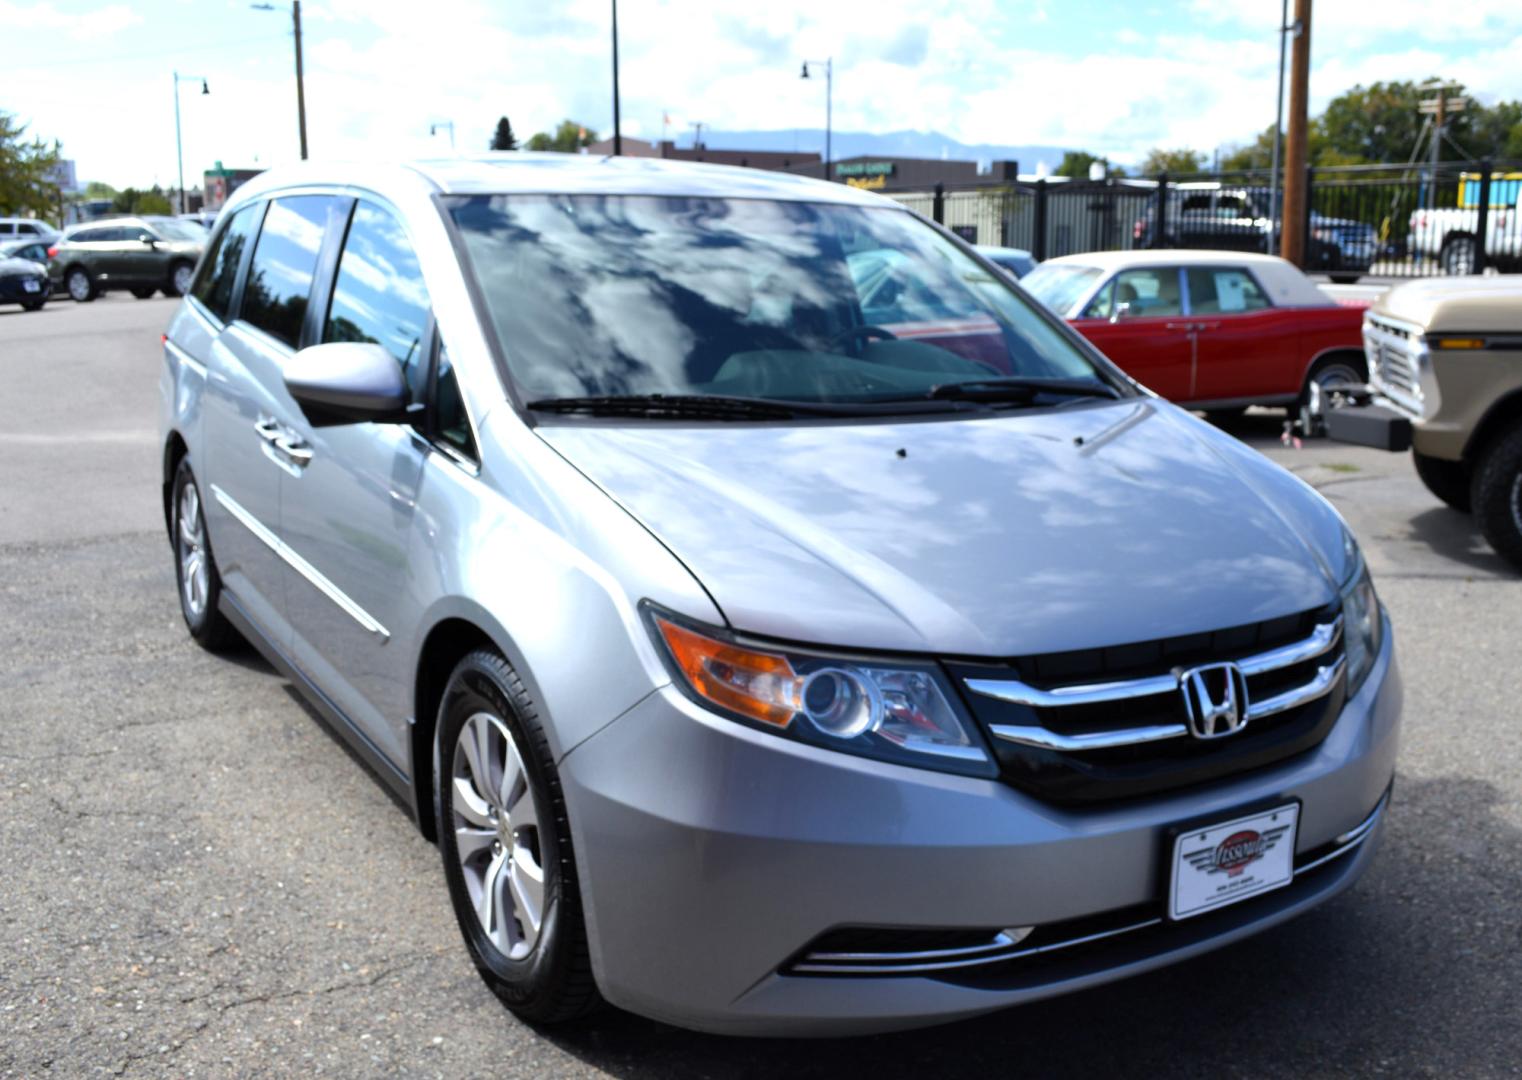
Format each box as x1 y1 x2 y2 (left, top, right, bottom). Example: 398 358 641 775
537 399 1342 657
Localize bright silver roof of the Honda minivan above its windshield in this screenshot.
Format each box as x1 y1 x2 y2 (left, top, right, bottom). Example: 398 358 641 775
226 151 898 207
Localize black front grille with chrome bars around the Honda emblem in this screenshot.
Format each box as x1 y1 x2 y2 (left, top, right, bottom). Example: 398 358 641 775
948 608 1345 803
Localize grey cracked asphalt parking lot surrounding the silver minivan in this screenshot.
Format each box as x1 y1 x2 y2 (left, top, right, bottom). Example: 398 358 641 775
0 295 1522 1080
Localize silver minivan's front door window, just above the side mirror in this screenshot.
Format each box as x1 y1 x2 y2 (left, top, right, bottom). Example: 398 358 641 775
323 202 429 402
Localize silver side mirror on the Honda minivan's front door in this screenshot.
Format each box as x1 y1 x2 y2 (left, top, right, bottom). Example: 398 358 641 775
285 341 406 427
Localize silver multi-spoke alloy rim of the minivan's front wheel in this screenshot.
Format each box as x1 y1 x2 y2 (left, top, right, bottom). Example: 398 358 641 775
451 712 545 960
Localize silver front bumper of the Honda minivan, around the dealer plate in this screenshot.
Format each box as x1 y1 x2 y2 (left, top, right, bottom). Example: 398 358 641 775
560 624 1402 1034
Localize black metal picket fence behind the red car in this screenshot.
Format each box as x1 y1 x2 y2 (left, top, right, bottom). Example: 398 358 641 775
893 161 1522 280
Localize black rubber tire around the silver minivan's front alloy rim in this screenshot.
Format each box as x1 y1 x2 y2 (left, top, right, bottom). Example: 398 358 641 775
434 650 601 1024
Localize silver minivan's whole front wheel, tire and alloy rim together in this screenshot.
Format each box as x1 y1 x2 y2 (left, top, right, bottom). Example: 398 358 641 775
435 650 601 1024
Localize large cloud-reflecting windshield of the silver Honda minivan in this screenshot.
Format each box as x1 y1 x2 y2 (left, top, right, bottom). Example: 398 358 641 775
449 195 1113 403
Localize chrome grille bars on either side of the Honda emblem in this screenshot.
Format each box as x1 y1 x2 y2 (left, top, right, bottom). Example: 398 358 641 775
965 615 1345 753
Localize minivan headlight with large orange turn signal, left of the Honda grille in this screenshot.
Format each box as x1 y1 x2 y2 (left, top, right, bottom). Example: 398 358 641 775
645 605 998 776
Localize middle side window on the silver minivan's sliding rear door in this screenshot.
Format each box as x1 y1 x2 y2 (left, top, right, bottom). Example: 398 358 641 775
240 195 333 348
